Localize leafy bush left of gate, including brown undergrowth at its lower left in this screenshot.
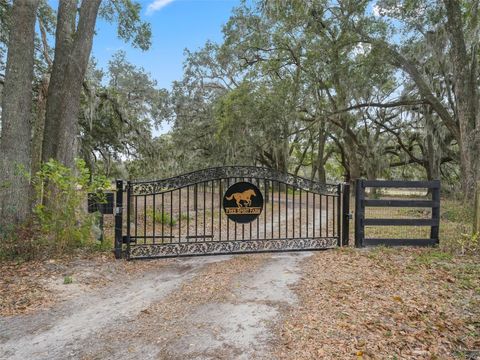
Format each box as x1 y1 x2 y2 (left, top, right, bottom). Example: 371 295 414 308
0 160 109 260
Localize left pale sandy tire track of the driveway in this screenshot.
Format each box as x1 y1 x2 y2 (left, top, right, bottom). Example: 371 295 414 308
0 256 231 360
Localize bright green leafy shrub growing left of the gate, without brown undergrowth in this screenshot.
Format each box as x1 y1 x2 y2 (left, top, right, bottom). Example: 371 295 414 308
32 160 109 253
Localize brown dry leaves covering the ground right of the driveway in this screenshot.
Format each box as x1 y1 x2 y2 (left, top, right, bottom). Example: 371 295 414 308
275 248 480 359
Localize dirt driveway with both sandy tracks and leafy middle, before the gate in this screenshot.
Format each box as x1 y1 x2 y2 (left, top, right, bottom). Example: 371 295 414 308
0 253 311 360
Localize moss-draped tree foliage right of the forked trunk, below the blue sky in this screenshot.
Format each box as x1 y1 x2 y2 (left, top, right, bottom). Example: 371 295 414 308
79 51 170 178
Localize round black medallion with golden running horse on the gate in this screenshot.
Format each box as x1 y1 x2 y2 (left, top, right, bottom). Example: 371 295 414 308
223 181 263 224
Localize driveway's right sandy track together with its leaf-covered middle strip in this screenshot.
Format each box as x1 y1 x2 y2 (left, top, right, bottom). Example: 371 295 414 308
73 252 311 359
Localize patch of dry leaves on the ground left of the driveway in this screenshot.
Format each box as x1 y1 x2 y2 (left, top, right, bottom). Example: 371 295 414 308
0 253 173 316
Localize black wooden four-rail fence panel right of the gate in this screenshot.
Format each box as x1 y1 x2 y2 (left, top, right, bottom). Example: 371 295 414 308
355 179 440 247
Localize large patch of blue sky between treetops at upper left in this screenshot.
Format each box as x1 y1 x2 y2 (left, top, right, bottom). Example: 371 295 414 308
92 0 240 89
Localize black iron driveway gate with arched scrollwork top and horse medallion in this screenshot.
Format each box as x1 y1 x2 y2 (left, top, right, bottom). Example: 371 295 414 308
115 167 349 259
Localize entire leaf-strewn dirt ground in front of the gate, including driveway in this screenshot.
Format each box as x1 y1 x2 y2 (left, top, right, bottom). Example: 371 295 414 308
0 248 480 359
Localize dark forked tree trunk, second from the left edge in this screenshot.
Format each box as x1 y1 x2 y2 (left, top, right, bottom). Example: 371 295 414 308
42 0 101 168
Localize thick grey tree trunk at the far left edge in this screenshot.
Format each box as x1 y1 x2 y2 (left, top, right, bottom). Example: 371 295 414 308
0 0 38 228
